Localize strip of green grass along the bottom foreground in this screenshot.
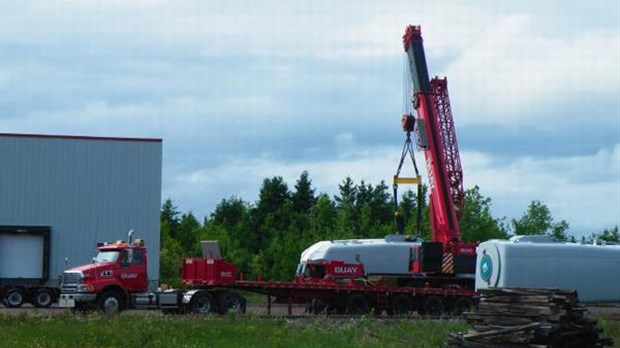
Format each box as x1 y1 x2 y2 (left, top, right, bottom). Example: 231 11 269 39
0 313 620 348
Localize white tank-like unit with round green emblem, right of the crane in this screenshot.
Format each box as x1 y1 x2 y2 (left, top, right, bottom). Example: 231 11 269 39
476 236 620 302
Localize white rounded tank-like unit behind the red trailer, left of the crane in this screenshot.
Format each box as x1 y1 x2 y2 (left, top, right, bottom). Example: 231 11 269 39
298 235 420 274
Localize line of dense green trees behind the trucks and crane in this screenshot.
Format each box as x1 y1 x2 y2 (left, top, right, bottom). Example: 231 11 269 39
160 172 619 286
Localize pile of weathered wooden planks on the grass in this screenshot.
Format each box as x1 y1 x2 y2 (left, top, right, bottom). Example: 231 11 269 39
448 288 613 348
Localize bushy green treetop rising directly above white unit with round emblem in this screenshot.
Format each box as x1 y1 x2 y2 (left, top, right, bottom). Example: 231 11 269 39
512 200 569 240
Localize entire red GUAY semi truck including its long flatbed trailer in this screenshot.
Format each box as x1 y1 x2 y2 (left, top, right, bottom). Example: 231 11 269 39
59 237 476 315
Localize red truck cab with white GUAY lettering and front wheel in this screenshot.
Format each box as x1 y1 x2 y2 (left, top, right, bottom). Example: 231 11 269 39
59 239 148 312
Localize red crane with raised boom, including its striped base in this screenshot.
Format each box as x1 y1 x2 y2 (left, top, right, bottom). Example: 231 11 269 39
395 25 476 274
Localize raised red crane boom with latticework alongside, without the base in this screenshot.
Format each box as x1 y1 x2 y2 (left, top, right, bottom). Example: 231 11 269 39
403 25 463 244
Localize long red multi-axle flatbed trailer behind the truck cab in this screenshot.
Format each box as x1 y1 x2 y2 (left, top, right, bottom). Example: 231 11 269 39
170 258 477 316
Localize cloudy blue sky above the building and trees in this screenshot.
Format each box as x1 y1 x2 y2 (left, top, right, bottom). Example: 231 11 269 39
0 0 620 236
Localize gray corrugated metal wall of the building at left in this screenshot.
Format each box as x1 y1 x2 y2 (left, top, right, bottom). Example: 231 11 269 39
0 133 162 287
